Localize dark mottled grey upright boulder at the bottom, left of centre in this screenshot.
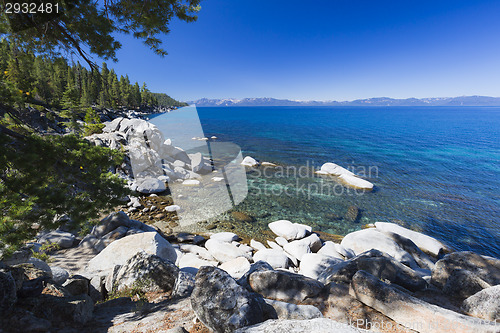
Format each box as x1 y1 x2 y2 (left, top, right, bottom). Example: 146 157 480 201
191 266 266 333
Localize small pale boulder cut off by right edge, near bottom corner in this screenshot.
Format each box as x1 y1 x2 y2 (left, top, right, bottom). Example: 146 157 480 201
462 285 500 321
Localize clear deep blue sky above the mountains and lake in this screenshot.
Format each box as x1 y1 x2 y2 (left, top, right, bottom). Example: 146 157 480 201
100 0 500 101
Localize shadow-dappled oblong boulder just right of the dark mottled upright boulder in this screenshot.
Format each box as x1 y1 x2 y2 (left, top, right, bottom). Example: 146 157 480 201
248 270 324 303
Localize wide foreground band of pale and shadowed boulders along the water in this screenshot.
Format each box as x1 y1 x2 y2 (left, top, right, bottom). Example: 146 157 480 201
0 212 500 332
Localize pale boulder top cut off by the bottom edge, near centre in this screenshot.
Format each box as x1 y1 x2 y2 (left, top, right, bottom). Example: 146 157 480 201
235 318 370 333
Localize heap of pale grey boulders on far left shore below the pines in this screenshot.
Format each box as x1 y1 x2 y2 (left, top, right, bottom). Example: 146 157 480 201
86 117 213 194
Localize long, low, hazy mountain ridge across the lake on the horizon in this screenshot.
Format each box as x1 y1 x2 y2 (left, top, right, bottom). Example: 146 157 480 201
188 96 500 107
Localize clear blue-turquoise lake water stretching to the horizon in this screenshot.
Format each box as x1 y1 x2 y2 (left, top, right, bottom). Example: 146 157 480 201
153 107 500 257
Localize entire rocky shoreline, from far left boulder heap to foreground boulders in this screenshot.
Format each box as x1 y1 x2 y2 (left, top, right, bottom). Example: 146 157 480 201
0 115 500 332
